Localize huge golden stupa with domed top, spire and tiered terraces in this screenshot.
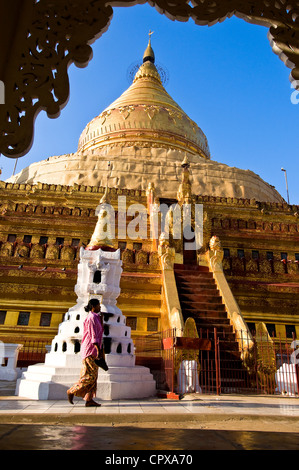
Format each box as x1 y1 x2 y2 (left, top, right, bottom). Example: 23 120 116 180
0 32 299 370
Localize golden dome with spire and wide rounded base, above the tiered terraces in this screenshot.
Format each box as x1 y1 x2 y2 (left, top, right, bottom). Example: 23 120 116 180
8 39 282 202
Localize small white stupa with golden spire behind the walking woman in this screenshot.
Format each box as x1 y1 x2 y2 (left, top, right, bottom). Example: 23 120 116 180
16 188 156 400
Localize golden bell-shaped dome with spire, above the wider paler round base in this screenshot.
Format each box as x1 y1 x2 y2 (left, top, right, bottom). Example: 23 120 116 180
78 41 210 159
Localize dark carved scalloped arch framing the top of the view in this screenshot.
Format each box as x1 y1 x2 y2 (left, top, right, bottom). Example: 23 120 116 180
0 0 299 158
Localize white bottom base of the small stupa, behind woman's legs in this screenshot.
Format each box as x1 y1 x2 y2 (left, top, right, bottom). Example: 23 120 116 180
15 364 156 400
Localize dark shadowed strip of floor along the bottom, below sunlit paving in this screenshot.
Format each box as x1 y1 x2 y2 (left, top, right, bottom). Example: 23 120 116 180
0 424 299 455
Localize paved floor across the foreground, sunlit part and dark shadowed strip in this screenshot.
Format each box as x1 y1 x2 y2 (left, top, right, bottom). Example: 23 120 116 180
0 382 299 452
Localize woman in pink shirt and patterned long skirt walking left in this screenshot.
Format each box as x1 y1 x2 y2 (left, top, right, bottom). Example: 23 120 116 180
67 299 104 406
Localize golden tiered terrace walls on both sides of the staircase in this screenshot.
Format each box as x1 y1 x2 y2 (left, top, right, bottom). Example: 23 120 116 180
0 182 299 343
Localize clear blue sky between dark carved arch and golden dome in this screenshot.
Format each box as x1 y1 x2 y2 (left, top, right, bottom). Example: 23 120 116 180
0 4 299 205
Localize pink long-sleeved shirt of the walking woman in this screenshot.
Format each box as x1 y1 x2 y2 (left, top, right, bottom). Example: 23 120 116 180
81 312 104 359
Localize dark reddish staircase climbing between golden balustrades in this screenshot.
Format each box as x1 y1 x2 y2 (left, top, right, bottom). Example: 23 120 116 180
174 264 248 393
